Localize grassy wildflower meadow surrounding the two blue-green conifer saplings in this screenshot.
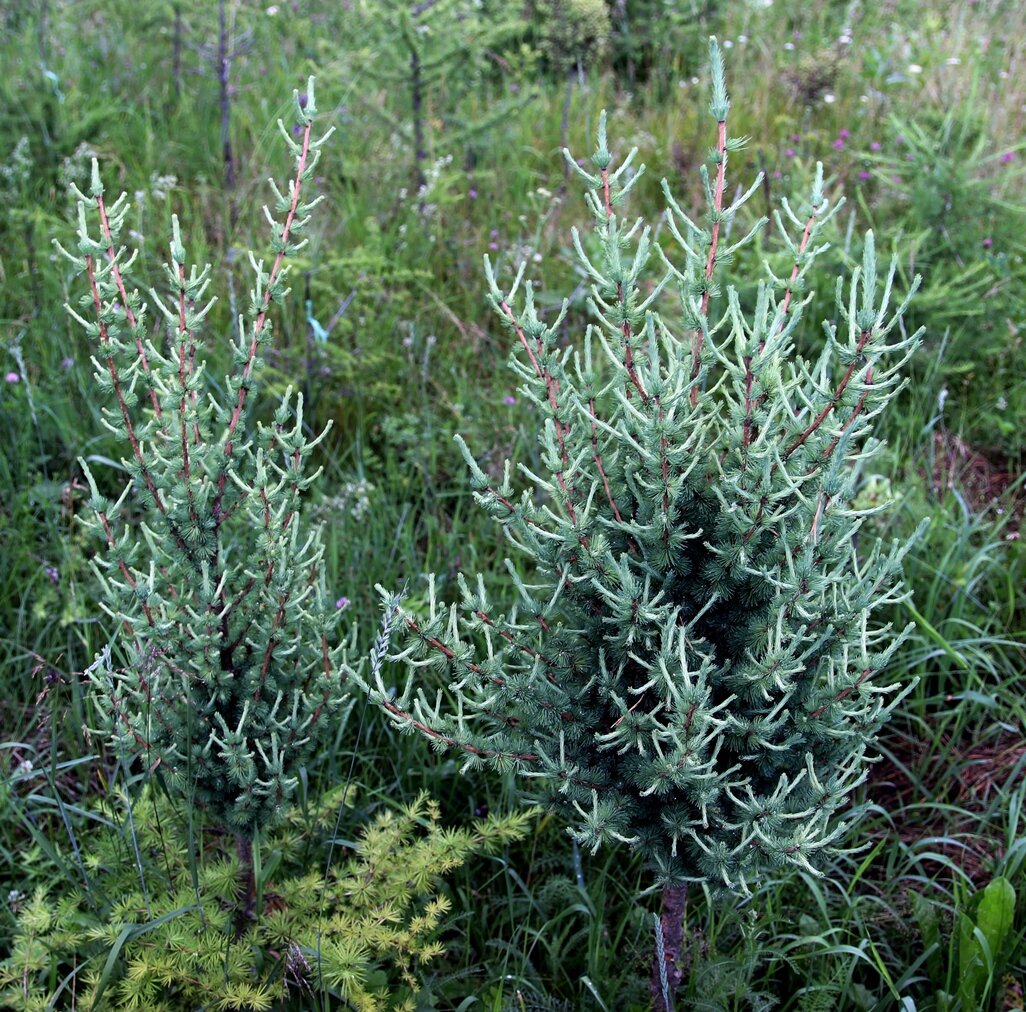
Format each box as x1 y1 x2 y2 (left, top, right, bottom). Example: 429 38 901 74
0 0 1026 1010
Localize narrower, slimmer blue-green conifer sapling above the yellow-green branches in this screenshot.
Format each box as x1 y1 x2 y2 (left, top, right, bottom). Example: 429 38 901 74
57 79 349 859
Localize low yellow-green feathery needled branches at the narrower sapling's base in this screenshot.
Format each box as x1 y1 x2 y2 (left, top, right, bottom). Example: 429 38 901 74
0 789 532 1012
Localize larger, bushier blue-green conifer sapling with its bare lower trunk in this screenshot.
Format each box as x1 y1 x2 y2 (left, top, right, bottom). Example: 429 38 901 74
366 40 919 1007
